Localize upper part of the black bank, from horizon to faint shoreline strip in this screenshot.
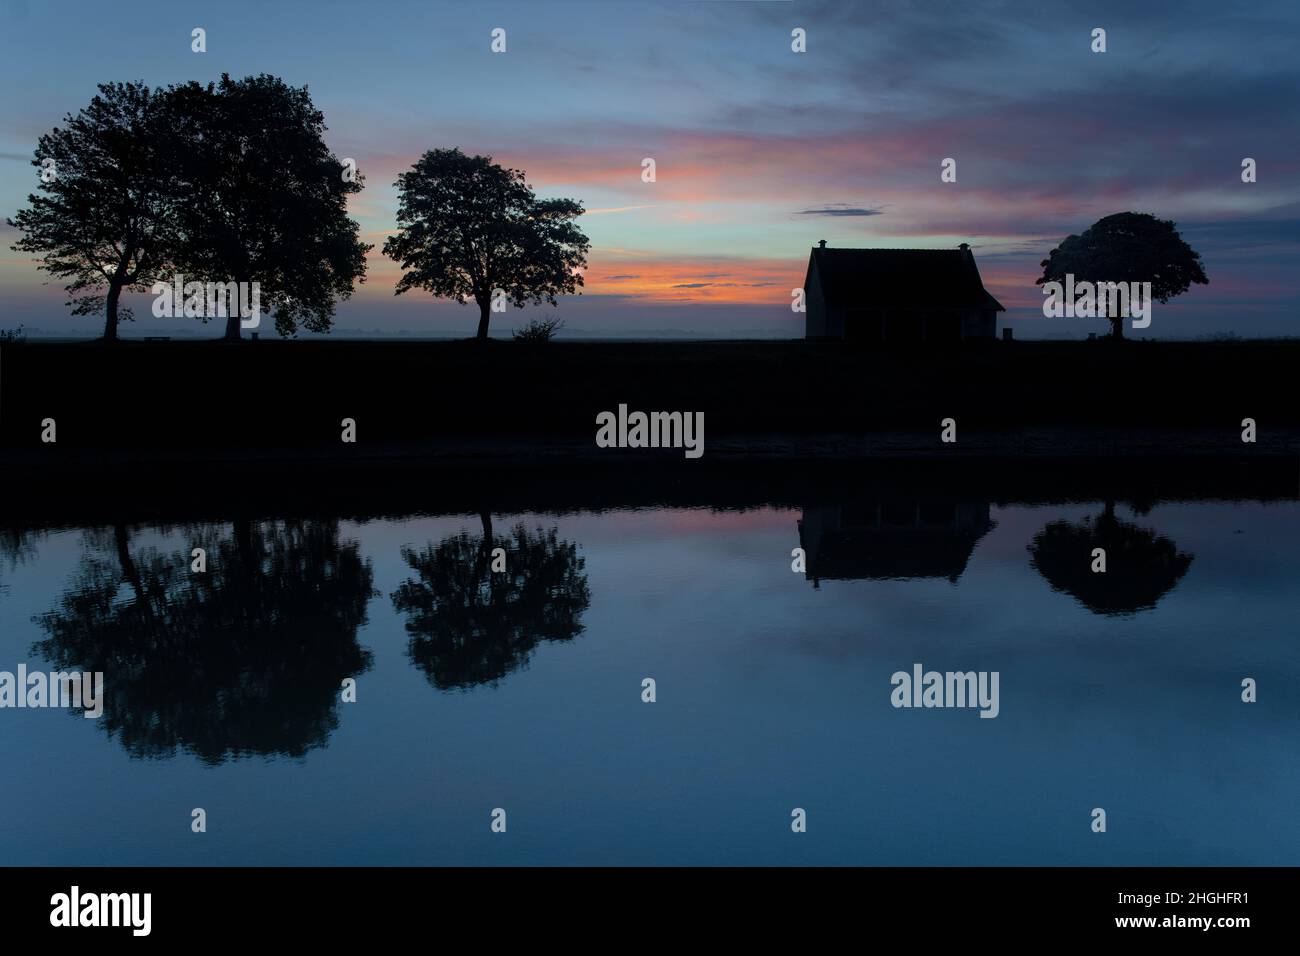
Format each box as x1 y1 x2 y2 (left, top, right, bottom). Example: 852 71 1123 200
0 341 1300 477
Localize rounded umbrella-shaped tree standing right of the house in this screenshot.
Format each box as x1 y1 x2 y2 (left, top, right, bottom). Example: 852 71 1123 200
1036 212 1209 338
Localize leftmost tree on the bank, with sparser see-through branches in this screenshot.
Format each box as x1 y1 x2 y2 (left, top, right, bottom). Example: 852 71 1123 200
9 83 177 341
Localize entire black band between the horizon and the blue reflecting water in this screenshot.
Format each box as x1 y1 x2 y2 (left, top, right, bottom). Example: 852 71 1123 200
0 342 1300 524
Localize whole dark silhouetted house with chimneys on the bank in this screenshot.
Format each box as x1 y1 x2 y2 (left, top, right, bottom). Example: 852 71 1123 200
803 239 1006 342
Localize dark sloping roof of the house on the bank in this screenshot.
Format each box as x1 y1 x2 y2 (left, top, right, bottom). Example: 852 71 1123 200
809 248 1006 312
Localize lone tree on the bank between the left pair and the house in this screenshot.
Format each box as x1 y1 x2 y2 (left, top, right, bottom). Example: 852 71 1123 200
384 150 590 339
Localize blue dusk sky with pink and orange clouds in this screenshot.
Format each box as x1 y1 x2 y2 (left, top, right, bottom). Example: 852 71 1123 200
0 0 1300 338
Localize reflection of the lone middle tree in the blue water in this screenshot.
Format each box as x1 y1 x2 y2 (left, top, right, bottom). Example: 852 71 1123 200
393 514 592 691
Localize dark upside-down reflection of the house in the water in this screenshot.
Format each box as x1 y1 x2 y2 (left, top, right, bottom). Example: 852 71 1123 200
798 497 995 588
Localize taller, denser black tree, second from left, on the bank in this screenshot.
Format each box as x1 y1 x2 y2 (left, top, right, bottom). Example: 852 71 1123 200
170 74 371 339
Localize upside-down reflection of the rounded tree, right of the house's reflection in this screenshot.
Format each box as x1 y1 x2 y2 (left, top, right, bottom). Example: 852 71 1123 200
1028 501 1192 614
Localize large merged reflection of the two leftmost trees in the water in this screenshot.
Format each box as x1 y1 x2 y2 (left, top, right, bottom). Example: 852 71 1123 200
34 520 376 763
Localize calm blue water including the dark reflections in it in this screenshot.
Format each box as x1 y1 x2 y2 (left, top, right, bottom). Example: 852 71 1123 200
0 496 1300 865
